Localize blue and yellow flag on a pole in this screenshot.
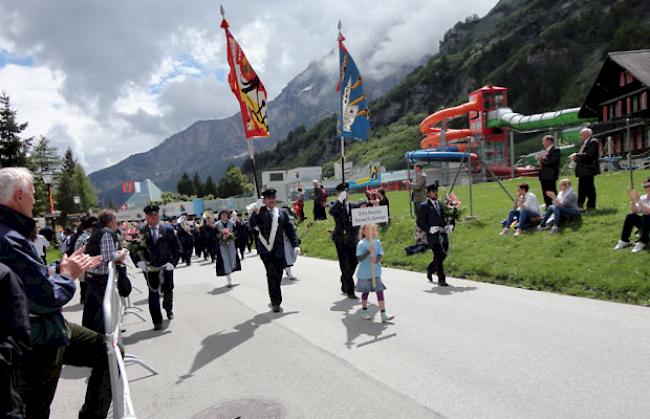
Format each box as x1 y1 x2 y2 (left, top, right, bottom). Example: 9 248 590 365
336 32 370 140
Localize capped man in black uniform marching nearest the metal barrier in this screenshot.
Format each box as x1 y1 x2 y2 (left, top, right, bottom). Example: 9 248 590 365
138 205 181 330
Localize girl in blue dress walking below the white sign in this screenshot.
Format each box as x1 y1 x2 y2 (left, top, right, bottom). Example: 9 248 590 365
355 224 395 323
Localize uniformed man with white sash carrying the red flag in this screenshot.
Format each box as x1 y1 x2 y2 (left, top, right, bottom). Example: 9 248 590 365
247 189 300 313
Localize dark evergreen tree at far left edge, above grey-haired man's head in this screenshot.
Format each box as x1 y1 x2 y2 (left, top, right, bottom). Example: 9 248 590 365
0 92 32 167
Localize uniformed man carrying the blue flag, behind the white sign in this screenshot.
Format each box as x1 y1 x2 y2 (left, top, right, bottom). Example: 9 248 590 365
330 182 359 299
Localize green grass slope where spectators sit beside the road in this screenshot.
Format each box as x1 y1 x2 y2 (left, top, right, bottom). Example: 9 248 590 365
299 170 650 305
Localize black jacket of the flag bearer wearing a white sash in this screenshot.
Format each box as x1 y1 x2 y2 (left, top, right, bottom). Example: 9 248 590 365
248 207 300 260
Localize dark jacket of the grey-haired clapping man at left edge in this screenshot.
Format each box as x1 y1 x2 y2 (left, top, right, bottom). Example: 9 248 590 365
0 205 76 346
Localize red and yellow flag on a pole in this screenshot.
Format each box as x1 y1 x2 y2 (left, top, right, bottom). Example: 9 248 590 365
221 19 269 138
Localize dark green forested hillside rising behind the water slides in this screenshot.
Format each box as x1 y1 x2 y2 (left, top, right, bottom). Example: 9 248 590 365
245 0 650 174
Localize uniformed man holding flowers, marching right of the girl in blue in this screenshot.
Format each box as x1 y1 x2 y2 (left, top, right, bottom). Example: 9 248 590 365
417 184 454 287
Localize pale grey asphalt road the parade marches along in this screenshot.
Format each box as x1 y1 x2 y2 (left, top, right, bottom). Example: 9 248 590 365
52 253 650 419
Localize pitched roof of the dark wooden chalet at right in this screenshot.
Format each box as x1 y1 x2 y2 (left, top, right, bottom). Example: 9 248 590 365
578 49 650 118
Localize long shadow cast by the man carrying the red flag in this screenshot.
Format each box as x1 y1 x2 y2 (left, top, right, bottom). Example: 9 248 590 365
176 311 299 384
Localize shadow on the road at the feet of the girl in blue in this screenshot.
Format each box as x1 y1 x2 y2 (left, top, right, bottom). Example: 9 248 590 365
330 298 397 349
